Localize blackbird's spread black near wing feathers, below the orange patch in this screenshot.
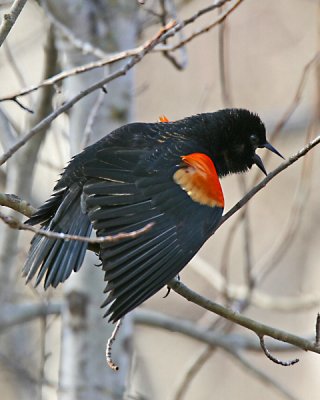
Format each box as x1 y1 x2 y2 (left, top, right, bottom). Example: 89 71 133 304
82 147 223 321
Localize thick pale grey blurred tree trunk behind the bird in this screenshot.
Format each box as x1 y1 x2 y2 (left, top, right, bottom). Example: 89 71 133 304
45 0 137 400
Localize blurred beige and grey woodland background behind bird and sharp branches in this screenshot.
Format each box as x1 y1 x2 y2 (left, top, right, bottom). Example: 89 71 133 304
0 0 320 400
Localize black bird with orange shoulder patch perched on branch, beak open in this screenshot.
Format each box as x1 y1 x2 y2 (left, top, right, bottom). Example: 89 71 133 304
23 109 280 322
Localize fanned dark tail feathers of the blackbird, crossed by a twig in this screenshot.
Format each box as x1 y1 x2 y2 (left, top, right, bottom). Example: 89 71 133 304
23 185 92 289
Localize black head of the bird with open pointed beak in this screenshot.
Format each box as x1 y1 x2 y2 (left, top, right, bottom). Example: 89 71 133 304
209 109 283 176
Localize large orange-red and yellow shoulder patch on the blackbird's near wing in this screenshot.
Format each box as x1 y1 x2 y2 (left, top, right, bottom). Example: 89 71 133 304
173 153 224 207
